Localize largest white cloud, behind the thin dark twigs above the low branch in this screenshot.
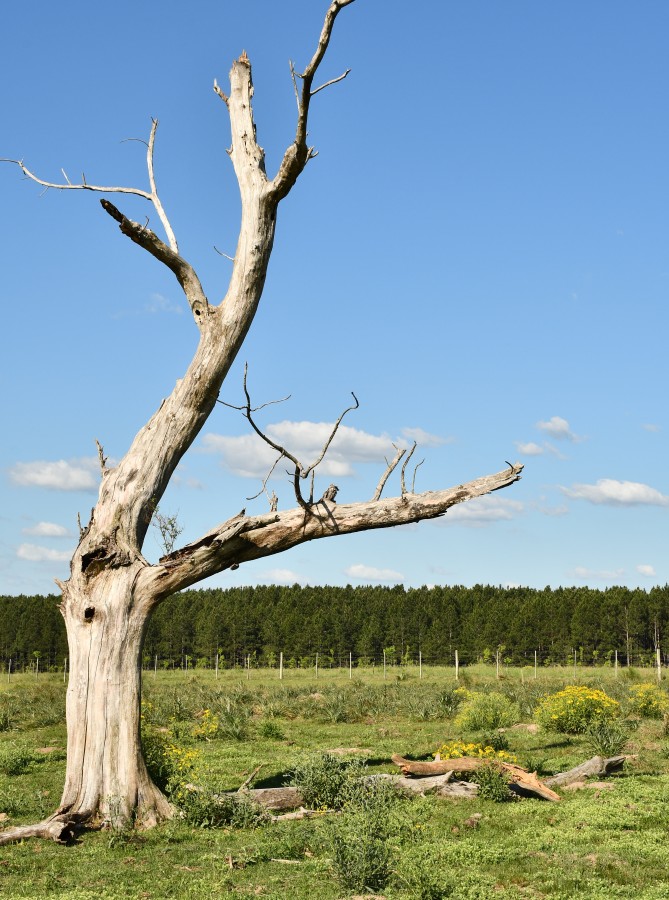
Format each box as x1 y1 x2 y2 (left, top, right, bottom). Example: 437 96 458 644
202 420 393 478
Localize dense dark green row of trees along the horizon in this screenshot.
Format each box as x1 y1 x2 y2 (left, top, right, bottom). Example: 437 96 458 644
0 584 669 668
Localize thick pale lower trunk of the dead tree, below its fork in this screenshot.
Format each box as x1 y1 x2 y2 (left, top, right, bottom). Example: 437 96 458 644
58 565 172 826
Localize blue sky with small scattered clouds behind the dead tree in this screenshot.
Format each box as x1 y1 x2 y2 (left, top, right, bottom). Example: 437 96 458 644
0 0 669 594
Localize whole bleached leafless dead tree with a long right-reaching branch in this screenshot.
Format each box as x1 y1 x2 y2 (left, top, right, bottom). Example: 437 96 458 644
0 0 522 844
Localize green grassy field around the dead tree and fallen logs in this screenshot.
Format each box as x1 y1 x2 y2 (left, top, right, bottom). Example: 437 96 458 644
0 667 669 900
